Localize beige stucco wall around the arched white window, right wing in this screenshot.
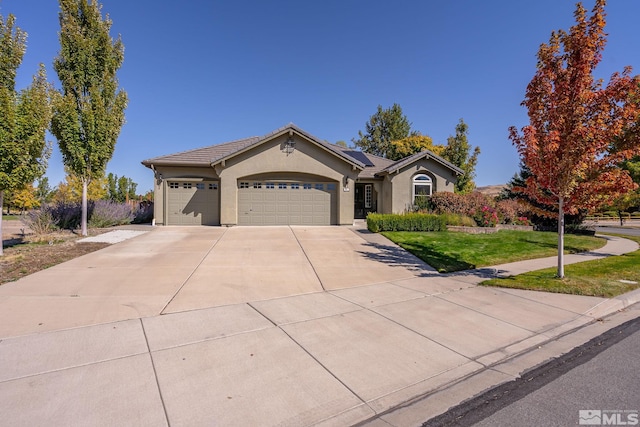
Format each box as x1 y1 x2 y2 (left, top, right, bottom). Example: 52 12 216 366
381 159 457 213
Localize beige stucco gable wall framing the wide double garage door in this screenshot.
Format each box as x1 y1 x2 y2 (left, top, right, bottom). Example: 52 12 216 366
215 134 358 225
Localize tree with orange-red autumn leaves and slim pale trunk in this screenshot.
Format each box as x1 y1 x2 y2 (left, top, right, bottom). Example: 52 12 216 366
509 0 640 278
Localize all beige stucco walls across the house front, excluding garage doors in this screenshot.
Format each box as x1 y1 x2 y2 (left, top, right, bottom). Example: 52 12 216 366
149 133 457 225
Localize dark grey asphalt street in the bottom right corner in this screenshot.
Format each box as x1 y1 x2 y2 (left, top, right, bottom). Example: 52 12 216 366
423 305 640 427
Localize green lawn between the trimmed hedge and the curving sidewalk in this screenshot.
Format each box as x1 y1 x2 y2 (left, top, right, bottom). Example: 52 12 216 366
382 230 606 273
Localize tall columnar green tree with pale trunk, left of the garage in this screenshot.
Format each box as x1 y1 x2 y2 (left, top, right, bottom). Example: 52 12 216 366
51 0 127 236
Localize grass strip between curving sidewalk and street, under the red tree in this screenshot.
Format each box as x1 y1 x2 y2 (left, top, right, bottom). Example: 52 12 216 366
481 236 640 298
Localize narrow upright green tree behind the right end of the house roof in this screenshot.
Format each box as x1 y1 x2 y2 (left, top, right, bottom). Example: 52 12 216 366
442 119 480 194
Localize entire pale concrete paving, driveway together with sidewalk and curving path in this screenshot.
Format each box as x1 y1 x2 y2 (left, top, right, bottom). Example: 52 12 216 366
0 227 640 426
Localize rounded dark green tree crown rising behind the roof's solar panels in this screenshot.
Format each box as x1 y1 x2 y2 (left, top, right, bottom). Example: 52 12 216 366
351 104 415 158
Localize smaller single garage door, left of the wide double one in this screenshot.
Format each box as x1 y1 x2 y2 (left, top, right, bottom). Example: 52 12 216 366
167 181 220 225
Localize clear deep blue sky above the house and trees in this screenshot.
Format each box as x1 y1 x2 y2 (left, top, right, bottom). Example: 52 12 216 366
0 0 640 193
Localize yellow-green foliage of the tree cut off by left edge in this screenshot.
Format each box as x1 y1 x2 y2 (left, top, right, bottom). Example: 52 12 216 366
0 15 51 255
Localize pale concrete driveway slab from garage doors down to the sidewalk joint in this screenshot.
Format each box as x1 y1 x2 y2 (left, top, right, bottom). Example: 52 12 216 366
0 227 431 337
